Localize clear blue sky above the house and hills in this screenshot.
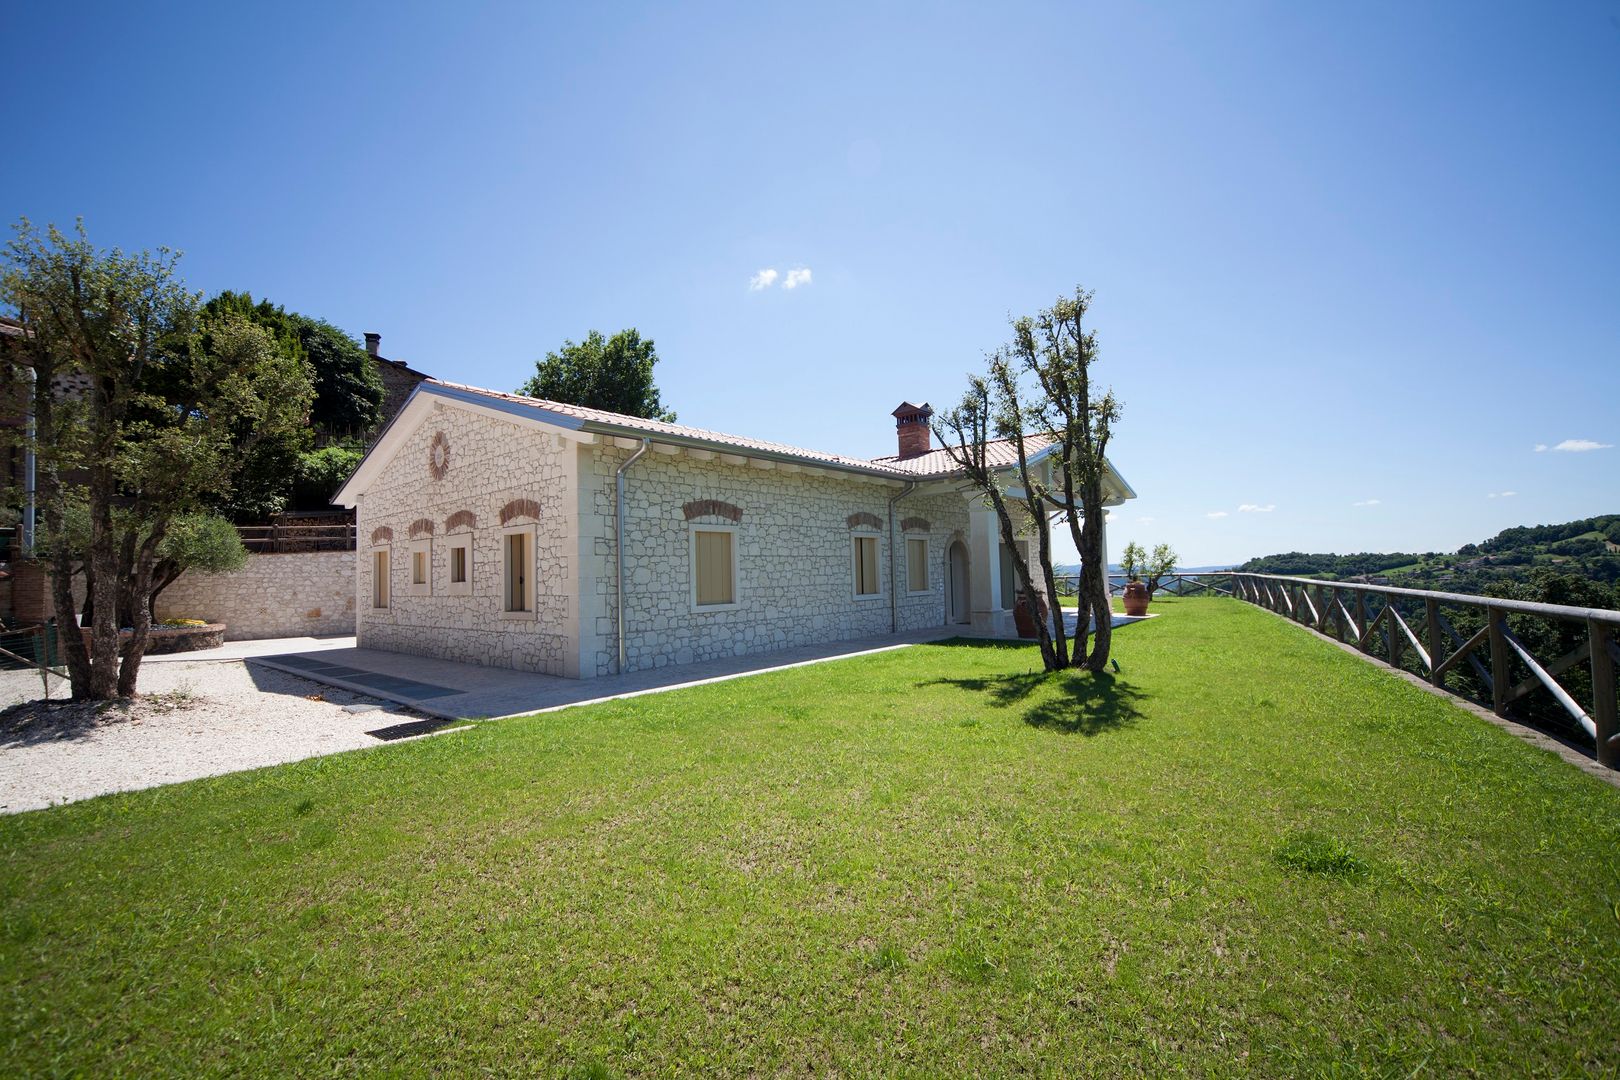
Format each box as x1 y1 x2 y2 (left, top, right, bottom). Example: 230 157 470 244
0 0 1620 565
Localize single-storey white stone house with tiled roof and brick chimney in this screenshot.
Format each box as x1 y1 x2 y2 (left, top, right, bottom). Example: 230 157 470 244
334 379 1136 678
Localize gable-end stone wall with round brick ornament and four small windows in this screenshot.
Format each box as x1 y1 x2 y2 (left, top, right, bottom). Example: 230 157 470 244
358 408 578 675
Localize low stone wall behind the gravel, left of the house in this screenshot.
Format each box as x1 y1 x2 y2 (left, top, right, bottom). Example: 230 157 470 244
157 551 355 641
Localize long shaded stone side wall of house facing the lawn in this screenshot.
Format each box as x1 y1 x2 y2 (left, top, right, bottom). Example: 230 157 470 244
582 447 969 675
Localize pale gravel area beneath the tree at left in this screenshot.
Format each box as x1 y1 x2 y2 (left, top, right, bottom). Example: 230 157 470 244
0 661 450 813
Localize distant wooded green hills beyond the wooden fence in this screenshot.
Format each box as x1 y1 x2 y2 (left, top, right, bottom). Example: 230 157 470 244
1238 513 1620 593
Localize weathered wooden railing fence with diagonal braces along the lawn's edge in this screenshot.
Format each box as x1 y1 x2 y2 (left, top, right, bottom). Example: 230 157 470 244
1228 573 1620 769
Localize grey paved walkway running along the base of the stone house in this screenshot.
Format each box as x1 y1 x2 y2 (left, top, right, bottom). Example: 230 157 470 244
245 615 1150 721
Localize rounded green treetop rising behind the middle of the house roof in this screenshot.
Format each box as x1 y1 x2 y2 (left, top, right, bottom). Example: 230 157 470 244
517 327 676 421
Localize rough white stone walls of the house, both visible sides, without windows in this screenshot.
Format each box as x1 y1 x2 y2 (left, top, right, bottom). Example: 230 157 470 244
352 402 1043 677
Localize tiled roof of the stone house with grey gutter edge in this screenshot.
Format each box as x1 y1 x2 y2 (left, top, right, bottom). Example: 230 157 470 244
334 379 1136 502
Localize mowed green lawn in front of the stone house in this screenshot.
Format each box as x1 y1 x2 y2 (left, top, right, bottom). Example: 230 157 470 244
0 599 1620 1077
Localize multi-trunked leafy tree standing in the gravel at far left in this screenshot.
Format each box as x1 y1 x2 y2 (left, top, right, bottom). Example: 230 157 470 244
0 220 311 699
